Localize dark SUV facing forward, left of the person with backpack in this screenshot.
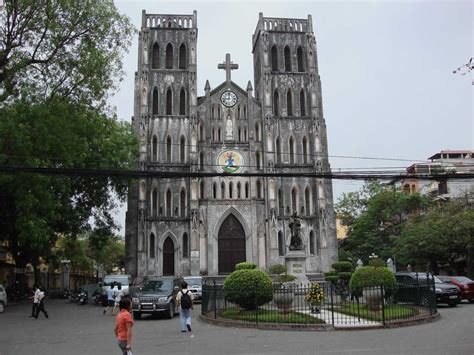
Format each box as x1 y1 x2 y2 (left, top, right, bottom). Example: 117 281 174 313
132 276 184 319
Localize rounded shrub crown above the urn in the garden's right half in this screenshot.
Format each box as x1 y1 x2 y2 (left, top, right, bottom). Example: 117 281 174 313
349 266 397 296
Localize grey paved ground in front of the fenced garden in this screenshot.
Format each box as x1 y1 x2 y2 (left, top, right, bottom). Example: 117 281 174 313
0 300 474 355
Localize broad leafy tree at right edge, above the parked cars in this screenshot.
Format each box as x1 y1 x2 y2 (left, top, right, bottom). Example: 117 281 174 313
394 202 474 274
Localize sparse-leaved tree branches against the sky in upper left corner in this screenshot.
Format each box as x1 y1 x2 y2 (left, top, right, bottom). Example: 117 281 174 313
0 0 134 107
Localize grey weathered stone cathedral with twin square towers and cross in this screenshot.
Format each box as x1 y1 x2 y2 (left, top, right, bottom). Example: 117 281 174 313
125 11 337 280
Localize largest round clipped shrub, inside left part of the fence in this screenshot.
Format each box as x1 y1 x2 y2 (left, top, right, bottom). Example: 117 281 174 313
224 269 273 310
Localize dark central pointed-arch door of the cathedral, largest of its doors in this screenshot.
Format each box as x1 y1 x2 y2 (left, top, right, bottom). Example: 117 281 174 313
217 214 245 274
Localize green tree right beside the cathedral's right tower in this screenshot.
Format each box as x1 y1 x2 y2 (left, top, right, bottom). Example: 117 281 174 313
338 185 430 261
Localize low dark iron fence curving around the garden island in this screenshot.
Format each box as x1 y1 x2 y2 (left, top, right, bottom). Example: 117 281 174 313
202 279 437 327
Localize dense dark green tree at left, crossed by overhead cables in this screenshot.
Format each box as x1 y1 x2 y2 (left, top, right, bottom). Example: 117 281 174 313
0 98 138 284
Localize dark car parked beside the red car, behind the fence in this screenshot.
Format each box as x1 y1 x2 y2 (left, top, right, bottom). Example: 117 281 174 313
395 272 461 307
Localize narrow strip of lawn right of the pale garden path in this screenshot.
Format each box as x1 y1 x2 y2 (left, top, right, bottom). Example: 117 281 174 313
334 303 418 321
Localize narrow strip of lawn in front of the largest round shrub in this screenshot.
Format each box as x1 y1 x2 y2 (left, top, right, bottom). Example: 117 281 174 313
219 307 325 324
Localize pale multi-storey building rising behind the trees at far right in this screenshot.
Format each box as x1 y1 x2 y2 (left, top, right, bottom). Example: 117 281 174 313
401 150 474 200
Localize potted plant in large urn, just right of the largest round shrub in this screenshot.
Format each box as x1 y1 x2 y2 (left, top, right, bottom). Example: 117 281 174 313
269 264 296 314
